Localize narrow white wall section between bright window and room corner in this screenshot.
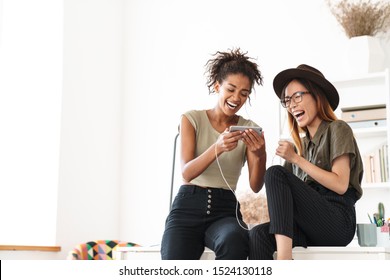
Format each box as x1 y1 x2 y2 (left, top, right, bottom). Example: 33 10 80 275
57 0 123 258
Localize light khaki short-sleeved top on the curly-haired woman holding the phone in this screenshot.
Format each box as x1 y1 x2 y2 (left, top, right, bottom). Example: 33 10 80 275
182 110 258 190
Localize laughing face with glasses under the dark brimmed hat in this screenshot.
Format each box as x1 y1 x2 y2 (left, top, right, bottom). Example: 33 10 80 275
284 80 321 134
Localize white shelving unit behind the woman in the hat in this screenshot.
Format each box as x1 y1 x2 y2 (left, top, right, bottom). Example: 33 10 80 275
332 69 390 223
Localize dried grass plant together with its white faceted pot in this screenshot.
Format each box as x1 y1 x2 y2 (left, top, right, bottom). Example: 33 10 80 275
326 0 390 73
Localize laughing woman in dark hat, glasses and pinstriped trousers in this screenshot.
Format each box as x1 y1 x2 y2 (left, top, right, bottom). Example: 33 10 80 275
249 65 363 259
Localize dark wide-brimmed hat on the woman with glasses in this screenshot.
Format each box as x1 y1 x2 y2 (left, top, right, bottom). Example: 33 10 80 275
273 64 340 110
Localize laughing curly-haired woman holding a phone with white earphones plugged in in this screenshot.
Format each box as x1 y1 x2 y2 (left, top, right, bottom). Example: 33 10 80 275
161 49 266 260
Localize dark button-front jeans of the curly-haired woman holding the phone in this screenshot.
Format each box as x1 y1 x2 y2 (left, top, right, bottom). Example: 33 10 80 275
161 185 249 260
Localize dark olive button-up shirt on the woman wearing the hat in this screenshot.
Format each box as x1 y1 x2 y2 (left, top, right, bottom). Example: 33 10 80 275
285 120 363 200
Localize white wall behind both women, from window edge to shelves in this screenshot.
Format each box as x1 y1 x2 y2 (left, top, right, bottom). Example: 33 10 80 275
4 0 390 258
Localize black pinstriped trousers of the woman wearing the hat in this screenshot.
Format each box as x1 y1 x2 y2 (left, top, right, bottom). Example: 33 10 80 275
249 166 356 260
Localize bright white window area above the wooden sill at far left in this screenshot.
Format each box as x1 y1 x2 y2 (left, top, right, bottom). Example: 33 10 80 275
0 0 63 259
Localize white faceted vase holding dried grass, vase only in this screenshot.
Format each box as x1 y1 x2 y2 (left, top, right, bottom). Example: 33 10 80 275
348 36 385 74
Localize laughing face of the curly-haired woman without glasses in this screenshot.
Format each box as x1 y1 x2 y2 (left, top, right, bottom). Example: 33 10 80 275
215 74 251 116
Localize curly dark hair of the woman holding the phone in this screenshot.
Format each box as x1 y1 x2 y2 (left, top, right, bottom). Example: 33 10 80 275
205 48 263 94
